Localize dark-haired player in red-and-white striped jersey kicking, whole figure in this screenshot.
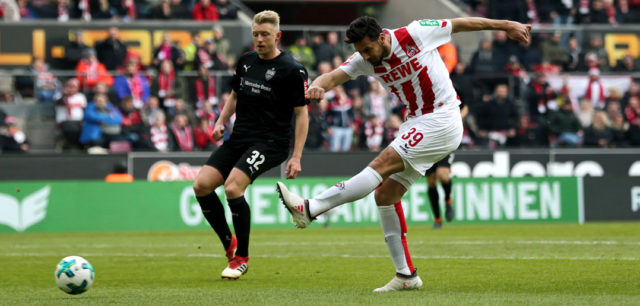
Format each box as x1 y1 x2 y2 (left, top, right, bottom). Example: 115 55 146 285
278 17 531 292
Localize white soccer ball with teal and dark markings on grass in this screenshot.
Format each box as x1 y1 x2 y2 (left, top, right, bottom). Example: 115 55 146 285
54 256 95 294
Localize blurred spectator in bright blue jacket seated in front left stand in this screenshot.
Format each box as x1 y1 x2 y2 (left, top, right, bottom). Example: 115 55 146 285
80 95 122 148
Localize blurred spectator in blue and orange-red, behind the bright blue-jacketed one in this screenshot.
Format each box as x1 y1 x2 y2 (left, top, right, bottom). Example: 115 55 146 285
113 62 151 108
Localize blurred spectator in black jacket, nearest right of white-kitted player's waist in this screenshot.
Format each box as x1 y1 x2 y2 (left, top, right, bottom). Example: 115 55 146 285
474 84 519 148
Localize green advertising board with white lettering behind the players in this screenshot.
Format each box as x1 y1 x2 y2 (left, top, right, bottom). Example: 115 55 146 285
0 177 583 232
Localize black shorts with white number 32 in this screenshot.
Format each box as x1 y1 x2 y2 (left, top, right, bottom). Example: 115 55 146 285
206 140 289 183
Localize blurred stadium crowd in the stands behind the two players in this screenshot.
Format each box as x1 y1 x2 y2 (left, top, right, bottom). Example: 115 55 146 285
0 0 640 153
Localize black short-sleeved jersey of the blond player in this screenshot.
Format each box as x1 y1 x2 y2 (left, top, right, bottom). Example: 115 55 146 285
231 51 308 145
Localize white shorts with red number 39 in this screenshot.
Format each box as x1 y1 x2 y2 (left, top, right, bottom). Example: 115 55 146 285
390 107 462 189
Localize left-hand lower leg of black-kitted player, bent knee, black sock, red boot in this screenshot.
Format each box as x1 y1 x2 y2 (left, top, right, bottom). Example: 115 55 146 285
193 165 237 261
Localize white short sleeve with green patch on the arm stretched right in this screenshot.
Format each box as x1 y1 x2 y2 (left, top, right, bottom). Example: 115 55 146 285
408 19 451 50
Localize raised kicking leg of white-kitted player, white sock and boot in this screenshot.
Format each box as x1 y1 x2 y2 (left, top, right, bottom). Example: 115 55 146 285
278 147 404 228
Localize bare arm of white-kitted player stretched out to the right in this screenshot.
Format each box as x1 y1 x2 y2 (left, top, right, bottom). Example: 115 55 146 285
451 17 531 45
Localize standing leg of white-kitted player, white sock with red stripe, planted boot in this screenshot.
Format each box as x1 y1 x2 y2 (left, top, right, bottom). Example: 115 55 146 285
374 178 422 292
